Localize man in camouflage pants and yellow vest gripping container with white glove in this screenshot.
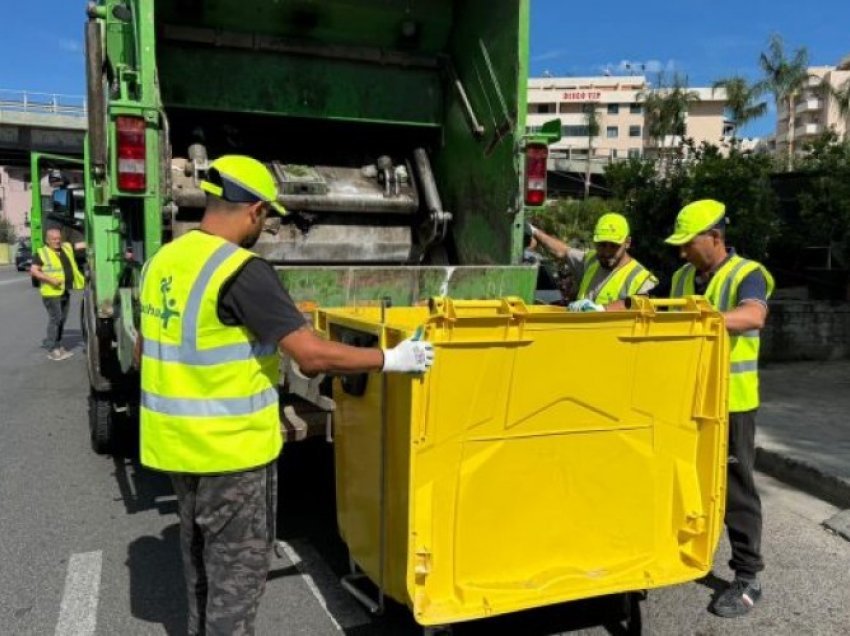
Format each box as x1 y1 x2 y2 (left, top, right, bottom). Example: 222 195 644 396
137 156 434 635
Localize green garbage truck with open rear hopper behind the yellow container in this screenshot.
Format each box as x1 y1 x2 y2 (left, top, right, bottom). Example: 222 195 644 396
39 0 560 453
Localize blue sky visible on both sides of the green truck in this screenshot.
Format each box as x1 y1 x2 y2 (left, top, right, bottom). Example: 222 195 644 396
0 0 850 135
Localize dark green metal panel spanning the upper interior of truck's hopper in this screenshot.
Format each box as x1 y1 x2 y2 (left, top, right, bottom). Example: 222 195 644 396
159 43 443 126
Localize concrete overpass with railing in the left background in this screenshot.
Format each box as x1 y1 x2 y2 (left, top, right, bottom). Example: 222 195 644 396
0 89 88 166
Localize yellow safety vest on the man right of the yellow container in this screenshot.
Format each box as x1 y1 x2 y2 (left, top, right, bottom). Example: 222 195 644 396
671 254 774 413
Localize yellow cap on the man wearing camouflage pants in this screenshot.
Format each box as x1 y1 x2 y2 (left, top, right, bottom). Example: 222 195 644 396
201 155 286 216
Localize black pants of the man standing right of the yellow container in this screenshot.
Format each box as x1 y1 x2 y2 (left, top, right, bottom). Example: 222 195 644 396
726 410 764 578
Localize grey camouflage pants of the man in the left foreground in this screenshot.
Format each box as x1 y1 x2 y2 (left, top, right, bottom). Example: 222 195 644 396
171 462 277 636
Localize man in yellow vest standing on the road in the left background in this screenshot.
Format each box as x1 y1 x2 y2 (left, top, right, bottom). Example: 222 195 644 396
30 228 85 362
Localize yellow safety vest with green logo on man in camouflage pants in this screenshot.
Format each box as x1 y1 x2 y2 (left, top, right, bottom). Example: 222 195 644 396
141 231 282 474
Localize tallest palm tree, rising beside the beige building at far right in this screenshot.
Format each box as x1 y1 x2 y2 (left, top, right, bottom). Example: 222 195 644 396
757 33 812 171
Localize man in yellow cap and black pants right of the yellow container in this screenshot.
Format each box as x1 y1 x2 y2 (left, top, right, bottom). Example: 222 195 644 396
666 199 774 618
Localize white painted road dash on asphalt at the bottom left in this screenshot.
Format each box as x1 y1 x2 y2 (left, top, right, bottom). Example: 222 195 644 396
56 550 103 636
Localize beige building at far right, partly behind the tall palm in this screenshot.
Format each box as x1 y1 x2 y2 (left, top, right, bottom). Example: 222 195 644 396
772 56 850 156
